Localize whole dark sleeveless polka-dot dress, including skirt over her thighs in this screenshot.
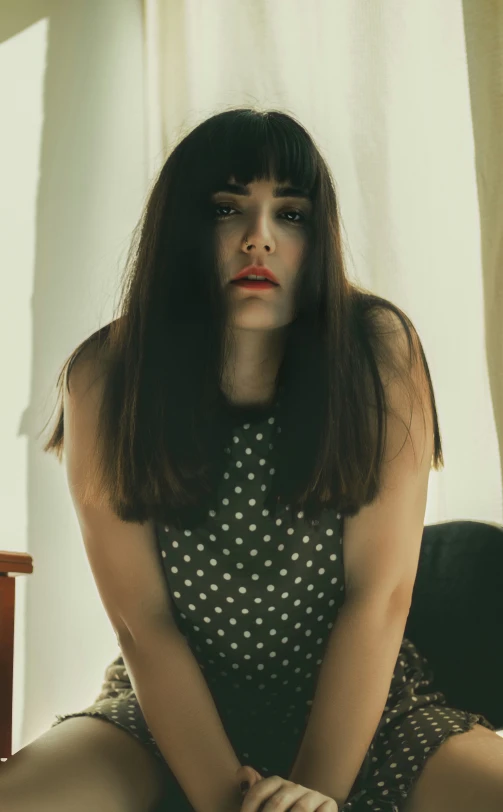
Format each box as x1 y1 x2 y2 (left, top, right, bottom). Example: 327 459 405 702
51 390 495 812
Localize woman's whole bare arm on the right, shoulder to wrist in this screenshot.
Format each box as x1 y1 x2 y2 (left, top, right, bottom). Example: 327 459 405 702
289 316 434 807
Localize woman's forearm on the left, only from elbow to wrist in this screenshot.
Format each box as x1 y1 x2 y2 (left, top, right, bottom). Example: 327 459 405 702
119 628 242 812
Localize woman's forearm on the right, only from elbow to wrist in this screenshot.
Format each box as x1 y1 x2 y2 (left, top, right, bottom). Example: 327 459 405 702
288 588 414 809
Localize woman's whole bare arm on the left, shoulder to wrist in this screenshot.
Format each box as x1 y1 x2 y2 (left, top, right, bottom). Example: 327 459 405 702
64 353 245 812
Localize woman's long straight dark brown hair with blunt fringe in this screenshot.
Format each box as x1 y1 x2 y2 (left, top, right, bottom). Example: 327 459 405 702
43 109 443 526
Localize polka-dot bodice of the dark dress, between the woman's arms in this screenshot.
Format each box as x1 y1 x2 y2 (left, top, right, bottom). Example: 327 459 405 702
159 416 344 738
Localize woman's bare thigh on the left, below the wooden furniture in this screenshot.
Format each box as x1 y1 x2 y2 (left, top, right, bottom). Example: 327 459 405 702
0 716 170 812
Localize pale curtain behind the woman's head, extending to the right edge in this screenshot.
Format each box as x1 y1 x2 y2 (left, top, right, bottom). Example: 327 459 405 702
144 0 503 524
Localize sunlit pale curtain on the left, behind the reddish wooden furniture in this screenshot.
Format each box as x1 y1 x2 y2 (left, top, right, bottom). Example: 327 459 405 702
0 0 148 752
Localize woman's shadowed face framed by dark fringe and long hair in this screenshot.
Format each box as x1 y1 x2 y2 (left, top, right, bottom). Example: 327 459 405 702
212 177 312 330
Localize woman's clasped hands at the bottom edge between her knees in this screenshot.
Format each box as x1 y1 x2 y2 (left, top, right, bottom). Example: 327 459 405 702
236 765 339 812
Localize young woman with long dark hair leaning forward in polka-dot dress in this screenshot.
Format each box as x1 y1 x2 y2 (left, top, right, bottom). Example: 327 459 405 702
0 109 501 812
